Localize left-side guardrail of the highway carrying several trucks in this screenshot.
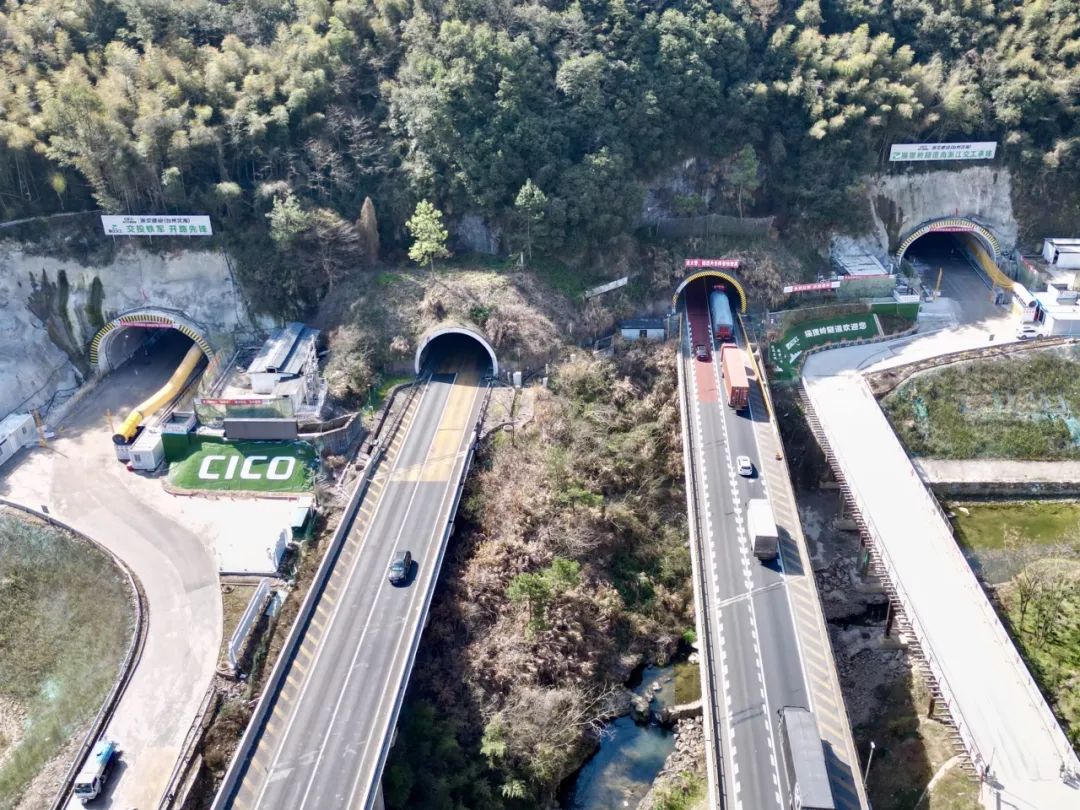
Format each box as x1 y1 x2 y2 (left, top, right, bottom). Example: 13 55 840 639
675 318 726 808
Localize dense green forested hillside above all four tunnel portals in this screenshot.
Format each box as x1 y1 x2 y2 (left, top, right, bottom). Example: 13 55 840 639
0 0 1080 258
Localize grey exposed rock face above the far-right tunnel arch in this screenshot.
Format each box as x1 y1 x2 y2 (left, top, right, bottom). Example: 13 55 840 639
867 166 1018 258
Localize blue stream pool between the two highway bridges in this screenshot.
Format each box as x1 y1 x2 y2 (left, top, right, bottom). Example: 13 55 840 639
561 664 697 810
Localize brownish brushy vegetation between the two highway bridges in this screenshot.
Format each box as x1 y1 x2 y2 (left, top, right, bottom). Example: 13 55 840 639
383 346 693 810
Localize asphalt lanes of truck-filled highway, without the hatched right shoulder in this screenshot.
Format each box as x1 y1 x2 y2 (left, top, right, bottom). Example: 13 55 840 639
681 285 808 810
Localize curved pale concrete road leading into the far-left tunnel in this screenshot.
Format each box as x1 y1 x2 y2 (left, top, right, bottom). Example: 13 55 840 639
0 330 221 810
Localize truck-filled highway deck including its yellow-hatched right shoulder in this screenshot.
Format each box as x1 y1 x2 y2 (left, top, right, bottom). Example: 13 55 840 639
679 285 865 810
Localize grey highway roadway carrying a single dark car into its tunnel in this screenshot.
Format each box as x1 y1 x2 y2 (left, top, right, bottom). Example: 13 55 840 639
225 359 485 810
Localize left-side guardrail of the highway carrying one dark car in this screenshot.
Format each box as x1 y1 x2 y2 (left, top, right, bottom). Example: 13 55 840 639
211 375 430 810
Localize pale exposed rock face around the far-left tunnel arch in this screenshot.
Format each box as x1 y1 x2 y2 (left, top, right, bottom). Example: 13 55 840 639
0 242 261 417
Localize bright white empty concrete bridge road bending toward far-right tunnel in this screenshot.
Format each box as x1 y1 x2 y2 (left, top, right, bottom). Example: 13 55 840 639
804 326 1080 810
